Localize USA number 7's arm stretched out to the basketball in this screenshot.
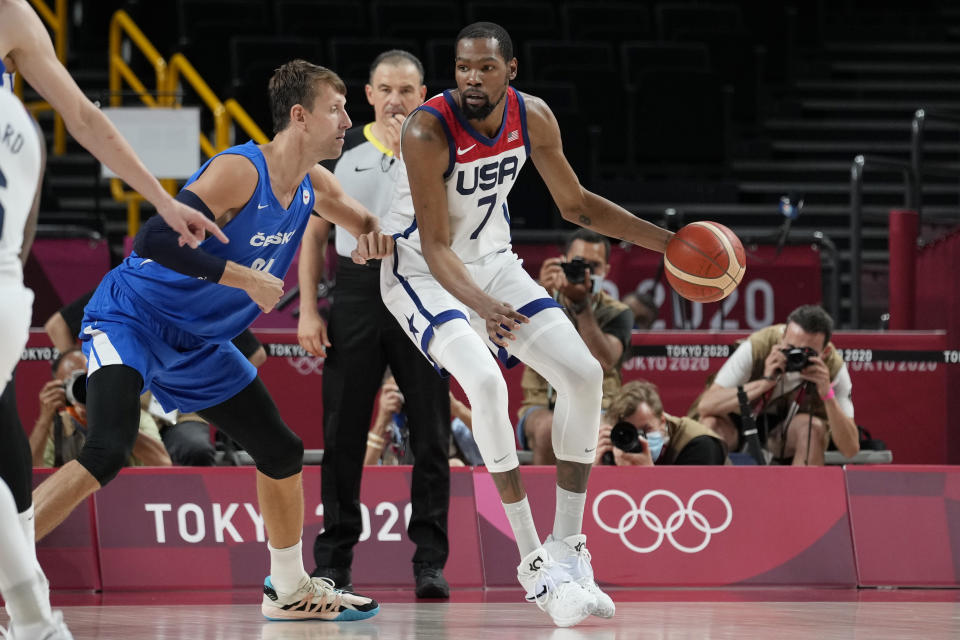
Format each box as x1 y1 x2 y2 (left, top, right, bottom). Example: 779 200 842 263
524 94 673 253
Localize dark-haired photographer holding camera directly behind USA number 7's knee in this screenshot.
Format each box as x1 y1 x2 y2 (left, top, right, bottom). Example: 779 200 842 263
517 229 633 464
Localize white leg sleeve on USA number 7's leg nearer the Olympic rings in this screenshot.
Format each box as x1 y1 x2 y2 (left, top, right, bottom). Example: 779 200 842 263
511 308 603 464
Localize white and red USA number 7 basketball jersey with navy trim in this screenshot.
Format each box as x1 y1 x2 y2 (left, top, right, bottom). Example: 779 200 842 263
383 87 530 271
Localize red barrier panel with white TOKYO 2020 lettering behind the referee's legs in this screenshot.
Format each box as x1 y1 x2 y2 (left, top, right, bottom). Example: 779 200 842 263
95 467 483 590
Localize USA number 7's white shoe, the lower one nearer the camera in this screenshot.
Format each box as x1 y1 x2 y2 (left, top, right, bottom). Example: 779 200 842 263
517 547 597 627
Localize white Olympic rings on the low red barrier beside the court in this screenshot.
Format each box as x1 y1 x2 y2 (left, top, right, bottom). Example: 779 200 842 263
593 489 733 553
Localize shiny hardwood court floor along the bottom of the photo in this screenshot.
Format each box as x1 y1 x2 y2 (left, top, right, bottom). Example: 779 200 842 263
0 590 960 640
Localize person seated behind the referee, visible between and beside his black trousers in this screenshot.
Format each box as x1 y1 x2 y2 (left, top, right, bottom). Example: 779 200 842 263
363 375 483 466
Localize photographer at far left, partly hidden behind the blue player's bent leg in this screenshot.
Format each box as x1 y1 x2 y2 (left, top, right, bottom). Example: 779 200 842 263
30 349 172 467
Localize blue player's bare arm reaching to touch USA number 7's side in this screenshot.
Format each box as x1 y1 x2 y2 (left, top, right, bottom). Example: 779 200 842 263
310 165 393 264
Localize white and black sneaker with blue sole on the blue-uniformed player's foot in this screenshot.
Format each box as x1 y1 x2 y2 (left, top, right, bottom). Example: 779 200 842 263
260 575 380 622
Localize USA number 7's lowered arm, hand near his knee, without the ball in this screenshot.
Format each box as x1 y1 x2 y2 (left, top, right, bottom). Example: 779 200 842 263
403 111 529 347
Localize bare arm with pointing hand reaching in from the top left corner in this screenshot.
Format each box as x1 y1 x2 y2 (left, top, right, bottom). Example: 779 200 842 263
0 0 227 247
